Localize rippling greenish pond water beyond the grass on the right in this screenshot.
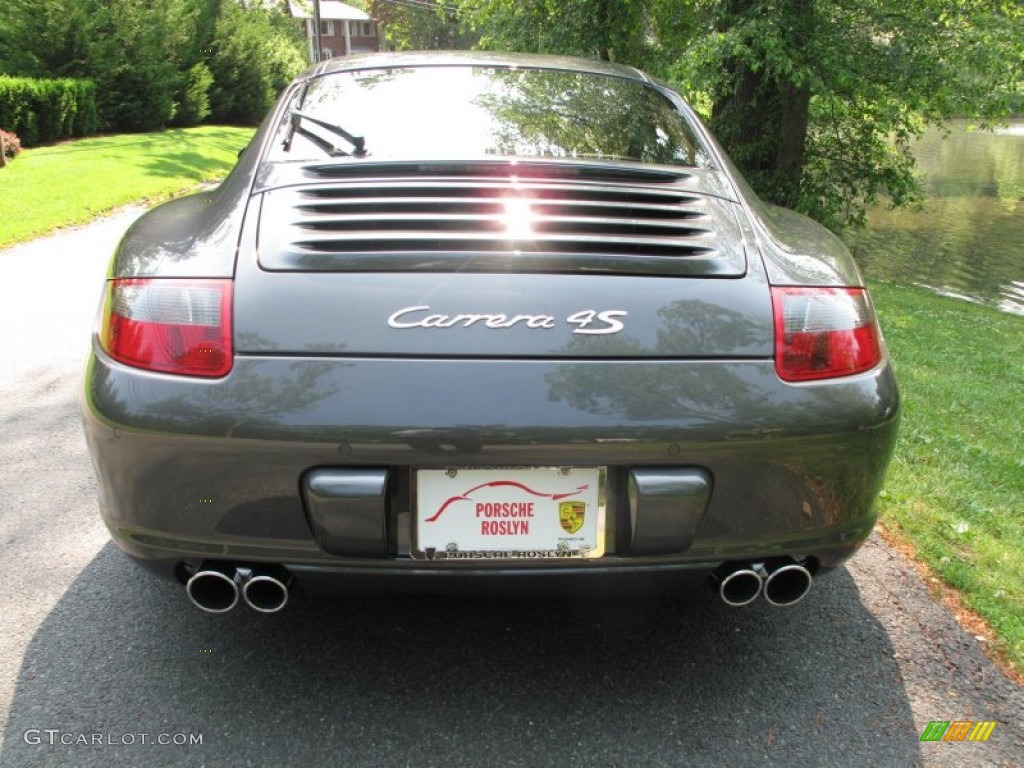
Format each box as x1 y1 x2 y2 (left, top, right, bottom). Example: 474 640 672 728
846 120 1024 314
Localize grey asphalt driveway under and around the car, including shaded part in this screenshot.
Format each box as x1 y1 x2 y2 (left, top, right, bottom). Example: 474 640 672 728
0 209 1024 768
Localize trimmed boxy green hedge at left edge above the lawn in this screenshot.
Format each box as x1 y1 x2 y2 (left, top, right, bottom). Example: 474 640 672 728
0 76 99 146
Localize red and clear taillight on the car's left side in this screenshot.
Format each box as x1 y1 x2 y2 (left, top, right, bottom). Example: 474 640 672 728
99 279 232 376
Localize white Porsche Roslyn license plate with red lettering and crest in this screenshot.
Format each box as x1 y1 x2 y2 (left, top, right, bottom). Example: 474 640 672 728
413 467 604 560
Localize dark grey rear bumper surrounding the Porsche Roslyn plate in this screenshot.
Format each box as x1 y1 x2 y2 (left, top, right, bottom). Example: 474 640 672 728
84 352 899 589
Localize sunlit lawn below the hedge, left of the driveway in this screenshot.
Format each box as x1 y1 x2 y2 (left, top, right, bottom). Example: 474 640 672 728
0 126 254 248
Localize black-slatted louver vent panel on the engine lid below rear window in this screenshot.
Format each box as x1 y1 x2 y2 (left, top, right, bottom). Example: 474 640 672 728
259 166 745 276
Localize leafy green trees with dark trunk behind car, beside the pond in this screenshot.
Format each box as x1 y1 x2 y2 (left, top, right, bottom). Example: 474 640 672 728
459 0 1024 229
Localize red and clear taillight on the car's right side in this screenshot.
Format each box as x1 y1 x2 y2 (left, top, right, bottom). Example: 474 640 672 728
772 288 882 381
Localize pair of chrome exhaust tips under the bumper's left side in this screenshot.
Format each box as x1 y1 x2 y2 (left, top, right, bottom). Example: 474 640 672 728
185 563 292 613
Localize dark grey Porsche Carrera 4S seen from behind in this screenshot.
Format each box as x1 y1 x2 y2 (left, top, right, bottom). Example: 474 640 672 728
84 53 899 612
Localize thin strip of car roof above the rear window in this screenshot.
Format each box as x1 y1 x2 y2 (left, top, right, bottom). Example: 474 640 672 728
300 51 654 83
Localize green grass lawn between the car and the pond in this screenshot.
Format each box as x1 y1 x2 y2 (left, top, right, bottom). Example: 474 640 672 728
871 284 1024 672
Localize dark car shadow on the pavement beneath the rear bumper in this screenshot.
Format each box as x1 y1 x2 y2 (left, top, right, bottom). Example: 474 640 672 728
0 545 922 767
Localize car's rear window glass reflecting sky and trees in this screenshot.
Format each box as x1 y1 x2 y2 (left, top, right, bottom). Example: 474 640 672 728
273 67 713 167
